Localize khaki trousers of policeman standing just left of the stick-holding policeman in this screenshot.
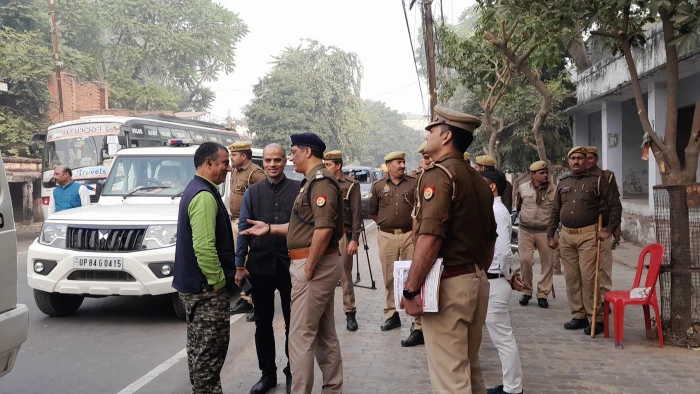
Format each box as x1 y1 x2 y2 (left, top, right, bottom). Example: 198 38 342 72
518 229 554 298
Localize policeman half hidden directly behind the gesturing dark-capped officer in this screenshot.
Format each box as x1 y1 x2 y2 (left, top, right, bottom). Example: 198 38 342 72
323 150 362 331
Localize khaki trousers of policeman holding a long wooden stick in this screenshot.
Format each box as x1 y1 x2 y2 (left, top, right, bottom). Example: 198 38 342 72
559 230 610 322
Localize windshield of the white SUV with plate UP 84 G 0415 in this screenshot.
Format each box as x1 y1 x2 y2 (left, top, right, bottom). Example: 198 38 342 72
102 156 194 197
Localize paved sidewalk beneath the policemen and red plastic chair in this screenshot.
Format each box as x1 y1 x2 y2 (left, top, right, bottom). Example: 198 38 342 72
222 229 700 394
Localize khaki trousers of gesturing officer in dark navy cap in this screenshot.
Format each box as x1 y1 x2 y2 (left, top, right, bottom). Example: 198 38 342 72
289 254 343 394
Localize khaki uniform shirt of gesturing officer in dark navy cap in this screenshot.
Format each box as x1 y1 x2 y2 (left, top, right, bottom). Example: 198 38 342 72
287 164 343 250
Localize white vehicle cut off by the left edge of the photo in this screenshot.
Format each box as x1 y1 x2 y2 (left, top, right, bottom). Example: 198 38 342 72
0 156 29 376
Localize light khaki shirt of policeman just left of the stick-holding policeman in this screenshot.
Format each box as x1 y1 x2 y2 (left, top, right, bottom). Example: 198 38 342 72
518 181 557 233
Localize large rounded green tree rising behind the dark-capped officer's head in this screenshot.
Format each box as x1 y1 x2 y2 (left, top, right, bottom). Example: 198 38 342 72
245 40 369 162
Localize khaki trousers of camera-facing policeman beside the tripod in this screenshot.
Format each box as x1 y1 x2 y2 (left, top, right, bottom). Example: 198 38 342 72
377 230 423 331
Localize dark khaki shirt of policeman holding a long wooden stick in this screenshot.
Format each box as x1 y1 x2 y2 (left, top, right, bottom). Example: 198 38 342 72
547 172 620 238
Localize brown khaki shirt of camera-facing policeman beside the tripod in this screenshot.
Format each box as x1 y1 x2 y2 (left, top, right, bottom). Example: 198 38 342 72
369 175 416 230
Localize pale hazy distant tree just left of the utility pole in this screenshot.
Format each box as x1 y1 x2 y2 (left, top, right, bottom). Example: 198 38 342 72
362 100 425 170
